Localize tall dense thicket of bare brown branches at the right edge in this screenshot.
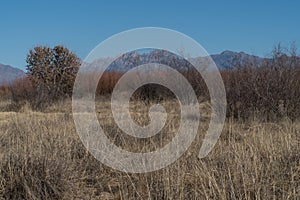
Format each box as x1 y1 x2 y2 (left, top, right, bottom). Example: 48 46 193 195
222 46 300 120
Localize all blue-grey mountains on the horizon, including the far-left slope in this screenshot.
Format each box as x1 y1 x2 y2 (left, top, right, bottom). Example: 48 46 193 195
0 50 266 85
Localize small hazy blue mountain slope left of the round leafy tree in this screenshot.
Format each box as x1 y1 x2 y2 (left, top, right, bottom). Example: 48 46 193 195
0 64 25 85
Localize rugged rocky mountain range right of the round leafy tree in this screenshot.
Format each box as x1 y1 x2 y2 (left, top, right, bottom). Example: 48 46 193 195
91 50 267 72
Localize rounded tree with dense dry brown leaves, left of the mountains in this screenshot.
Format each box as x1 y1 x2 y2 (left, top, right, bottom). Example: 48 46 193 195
26 46 80 100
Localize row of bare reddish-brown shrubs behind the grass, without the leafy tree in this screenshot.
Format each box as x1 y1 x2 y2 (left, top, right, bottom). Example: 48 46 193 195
5 46 300 120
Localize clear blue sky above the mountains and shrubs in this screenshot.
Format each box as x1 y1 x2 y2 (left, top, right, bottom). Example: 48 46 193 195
0 0 300 69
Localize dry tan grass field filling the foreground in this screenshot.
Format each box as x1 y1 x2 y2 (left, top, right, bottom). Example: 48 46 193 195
0 102 300 199
